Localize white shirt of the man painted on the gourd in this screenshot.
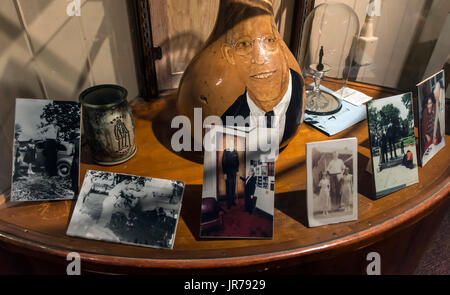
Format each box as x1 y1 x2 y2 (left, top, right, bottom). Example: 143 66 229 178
246 71 292 142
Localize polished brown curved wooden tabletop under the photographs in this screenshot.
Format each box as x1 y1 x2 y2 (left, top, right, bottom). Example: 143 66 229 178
0 84 450 273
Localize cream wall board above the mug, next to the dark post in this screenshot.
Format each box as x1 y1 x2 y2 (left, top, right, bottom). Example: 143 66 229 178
80 0 139 100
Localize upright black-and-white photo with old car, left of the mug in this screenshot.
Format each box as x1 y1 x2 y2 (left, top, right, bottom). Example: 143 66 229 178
11 98 81 201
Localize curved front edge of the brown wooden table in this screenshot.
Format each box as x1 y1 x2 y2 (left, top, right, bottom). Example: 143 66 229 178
0 176 444 270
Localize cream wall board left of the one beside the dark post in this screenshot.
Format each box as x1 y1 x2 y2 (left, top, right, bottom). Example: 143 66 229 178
17 0 93 100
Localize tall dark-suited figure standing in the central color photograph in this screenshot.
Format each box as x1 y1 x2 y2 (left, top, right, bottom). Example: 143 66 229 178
222 149 239 209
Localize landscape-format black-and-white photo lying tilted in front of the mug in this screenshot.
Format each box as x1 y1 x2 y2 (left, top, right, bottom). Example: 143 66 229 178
67 170 185 249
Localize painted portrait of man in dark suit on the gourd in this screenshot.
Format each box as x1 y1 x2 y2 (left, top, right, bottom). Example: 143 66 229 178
221 15 304 143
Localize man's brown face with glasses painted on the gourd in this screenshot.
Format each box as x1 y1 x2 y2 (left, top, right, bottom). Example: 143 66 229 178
224 15 289 106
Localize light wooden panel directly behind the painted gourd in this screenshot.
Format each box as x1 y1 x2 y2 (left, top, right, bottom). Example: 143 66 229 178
149 0 294 90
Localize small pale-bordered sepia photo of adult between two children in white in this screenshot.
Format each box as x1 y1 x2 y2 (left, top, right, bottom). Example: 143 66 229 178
306 138 358 227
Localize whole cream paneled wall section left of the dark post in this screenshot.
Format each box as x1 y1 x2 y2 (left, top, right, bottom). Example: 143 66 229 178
0 0 139 192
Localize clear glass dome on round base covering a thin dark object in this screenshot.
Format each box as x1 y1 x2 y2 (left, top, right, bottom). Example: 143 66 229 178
298 3 359 115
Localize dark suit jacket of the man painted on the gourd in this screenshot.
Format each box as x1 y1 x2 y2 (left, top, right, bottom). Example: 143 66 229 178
221 69 305 142
